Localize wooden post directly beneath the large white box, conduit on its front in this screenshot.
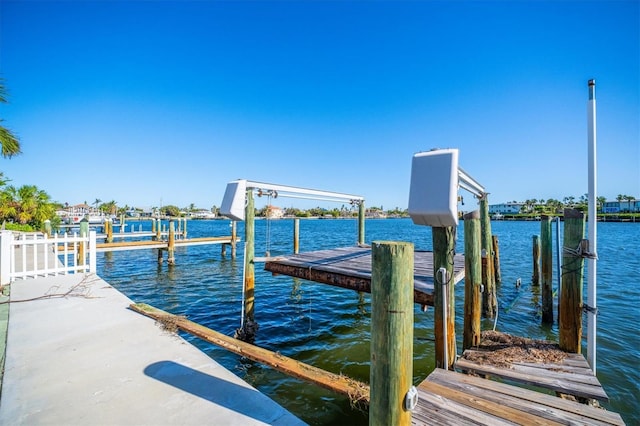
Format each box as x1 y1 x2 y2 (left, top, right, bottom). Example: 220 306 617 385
431 226 456 369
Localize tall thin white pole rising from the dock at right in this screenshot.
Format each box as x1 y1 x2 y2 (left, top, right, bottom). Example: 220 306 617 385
587 80 598 374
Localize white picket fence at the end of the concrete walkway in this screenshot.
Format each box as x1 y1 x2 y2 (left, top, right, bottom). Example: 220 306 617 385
0 231 96 285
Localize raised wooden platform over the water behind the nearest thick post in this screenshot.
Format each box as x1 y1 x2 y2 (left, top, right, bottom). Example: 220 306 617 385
264 246 464 306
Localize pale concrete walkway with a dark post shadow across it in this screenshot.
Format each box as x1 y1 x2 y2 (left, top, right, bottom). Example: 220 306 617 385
0 274 304 425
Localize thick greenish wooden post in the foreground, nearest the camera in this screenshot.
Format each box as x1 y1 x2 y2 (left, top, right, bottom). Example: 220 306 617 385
369 241 413 426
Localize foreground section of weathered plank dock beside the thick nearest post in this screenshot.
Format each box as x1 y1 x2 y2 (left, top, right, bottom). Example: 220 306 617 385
412 369 624 425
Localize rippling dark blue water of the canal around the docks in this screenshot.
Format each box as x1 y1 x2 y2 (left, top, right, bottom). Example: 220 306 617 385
98 219 640 425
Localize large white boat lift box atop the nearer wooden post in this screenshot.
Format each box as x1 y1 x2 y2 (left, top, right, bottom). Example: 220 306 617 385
409 148 459 227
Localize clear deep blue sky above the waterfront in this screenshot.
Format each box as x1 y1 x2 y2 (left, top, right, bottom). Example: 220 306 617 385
0 0 640 209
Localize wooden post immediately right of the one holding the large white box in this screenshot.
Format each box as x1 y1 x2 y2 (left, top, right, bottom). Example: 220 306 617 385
462 210 482 350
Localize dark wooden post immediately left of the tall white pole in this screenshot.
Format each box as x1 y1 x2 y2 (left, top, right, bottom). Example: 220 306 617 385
558 209 588 353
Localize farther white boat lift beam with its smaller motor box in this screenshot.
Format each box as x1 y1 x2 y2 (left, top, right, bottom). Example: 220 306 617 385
220 179 364 221
